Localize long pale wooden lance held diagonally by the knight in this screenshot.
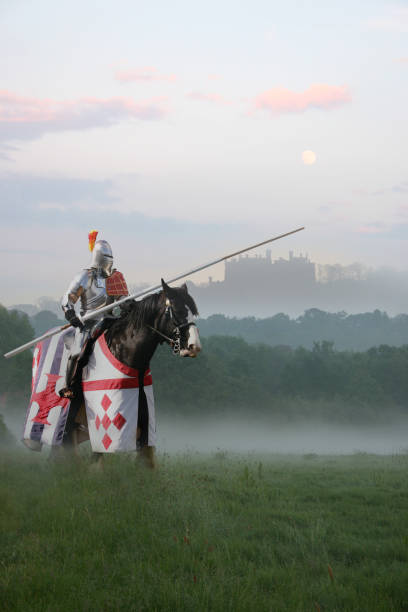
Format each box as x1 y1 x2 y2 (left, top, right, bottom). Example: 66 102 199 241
4 227 305 358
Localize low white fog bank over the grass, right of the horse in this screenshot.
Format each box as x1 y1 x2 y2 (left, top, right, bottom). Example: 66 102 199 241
157 417 408 455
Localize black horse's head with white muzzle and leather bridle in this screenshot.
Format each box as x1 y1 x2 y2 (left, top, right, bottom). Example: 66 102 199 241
161 279 201 357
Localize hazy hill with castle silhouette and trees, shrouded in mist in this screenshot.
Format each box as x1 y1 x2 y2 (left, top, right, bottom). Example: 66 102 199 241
190 250 408 317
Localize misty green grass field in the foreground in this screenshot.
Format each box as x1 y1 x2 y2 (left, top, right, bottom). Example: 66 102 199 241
0 452 408 612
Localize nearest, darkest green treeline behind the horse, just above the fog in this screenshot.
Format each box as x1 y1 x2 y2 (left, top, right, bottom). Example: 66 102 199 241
0 307 408 422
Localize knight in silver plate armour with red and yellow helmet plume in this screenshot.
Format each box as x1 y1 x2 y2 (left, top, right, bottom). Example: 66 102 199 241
60 230 128 398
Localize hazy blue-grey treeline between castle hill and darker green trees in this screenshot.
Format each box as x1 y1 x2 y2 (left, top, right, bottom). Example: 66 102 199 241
198 308 408 351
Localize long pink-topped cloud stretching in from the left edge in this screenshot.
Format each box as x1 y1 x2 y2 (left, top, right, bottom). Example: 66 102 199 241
0 90 165 140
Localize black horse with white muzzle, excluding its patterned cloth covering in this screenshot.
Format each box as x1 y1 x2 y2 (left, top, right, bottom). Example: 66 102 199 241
58 279 201 467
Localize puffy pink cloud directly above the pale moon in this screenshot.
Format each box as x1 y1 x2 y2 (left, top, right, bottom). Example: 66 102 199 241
254 83 351 115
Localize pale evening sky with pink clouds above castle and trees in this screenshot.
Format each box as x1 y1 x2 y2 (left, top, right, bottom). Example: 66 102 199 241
0 0 408 305
